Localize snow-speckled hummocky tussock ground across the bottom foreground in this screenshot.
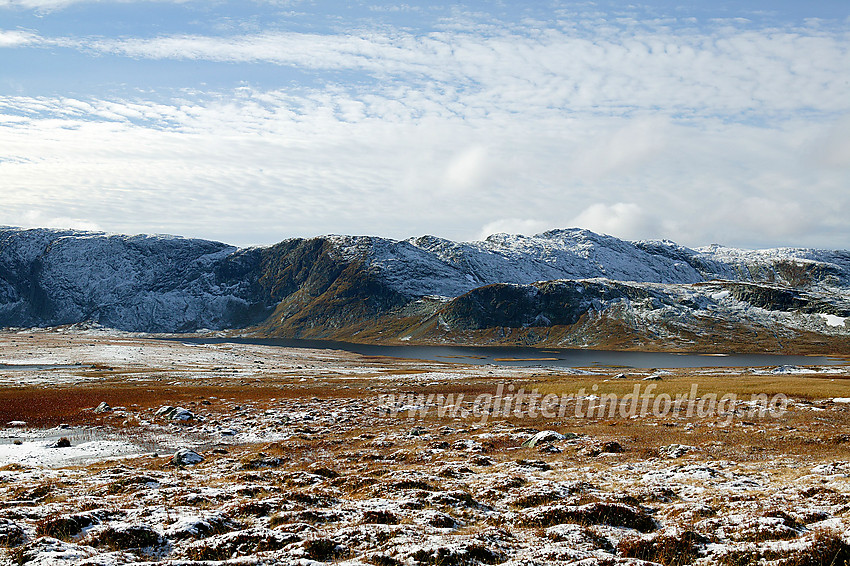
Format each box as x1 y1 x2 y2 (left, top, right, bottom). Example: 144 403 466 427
6 401 850 566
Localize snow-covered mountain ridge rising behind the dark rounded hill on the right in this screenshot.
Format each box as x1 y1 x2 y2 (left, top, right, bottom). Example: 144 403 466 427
322 229 850 297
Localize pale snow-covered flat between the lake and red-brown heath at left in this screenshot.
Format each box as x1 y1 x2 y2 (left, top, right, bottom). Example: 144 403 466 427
0 331 536 387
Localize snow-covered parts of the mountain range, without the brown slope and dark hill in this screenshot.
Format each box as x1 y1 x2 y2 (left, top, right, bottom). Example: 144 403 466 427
0 228 850 334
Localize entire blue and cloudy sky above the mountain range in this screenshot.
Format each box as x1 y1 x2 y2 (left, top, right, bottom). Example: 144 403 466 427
0 0 850 249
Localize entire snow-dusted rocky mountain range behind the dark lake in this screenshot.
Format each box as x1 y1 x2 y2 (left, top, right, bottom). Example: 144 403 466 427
0 228 850 352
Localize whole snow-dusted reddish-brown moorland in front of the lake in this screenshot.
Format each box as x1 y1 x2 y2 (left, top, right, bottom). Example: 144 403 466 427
0 332 850 566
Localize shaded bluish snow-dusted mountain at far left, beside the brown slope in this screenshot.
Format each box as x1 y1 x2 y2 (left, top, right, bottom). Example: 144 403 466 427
0 229 268 332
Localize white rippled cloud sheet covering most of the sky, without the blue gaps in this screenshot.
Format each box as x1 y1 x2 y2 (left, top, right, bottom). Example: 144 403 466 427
0 13 850 247
